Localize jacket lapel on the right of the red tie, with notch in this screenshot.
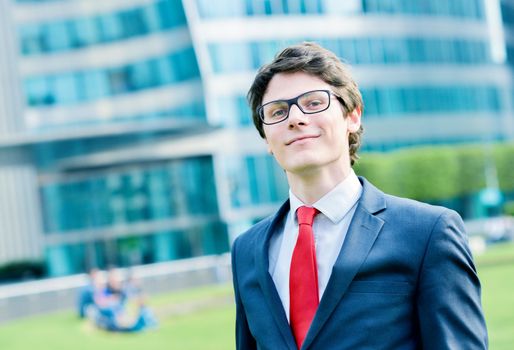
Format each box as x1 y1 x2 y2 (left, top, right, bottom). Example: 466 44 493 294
302 178 385 349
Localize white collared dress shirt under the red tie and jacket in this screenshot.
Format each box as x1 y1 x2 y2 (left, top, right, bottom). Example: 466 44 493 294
269 170 362 320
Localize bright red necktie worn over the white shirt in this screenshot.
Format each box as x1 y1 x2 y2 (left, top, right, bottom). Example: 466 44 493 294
289 206 319 349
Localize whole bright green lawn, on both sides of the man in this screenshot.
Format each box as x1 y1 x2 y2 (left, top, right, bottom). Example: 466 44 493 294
0 243 514 350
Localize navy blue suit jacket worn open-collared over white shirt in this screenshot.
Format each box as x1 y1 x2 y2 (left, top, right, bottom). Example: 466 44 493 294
232 178 487 350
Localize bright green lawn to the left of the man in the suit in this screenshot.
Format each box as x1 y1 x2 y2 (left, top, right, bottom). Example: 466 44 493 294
0 285 235 350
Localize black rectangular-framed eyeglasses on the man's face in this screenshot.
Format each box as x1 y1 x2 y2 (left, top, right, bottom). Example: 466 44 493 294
257 90 339 125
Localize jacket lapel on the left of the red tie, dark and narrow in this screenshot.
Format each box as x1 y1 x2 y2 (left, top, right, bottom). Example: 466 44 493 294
255 201 296 349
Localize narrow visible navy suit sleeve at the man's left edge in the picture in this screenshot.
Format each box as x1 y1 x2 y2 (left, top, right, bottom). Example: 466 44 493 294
232 239 257 350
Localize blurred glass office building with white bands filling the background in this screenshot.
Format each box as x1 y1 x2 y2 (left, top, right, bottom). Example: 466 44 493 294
0 0 514 276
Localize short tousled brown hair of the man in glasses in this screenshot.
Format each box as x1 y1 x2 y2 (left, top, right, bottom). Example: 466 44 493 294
247 42 363 165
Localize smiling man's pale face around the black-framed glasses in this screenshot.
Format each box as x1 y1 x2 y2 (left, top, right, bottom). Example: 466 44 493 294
262 72 360 176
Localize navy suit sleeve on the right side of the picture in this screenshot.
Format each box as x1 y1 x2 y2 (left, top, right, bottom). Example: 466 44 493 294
416 210 488 350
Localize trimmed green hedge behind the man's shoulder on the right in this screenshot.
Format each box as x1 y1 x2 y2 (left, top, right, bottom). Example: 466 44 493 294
355 144 514 201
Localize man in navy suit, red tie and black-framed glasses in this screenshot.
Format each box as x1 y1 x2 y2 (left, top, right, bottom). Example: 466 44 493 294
232 43 487 350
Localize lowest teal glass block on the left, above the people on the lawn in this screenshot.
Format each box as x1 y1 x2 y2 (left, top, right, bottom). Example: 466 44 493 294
41 157 228 274
